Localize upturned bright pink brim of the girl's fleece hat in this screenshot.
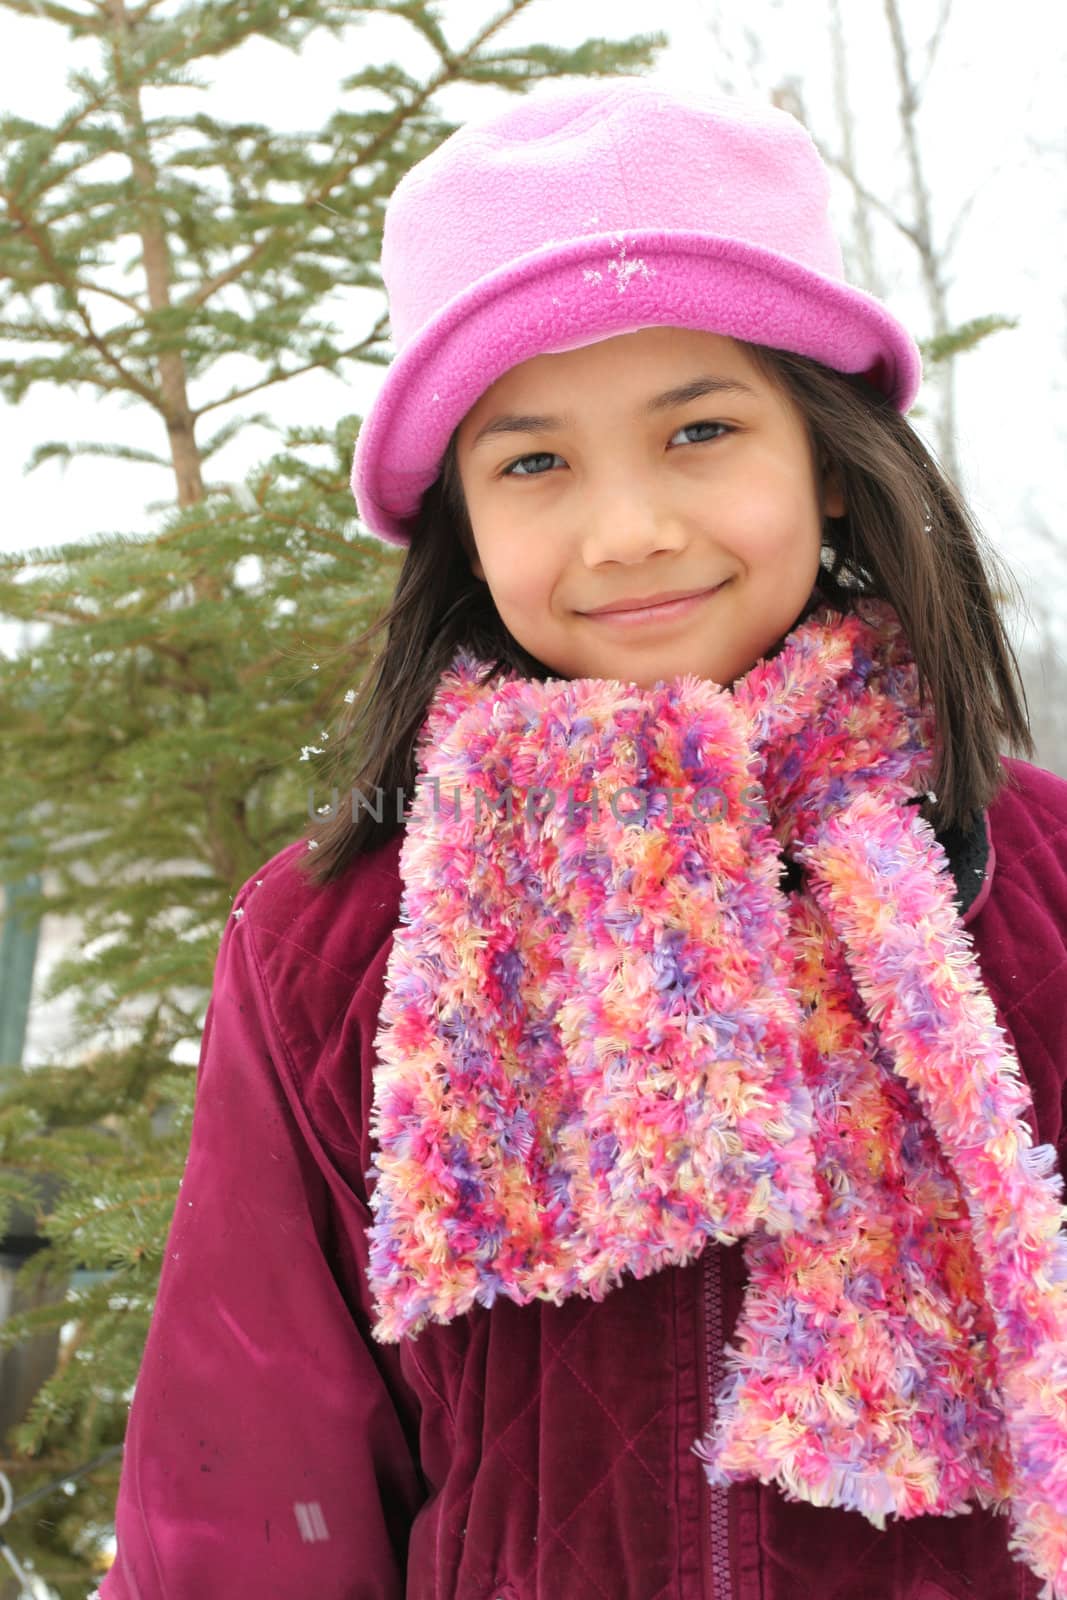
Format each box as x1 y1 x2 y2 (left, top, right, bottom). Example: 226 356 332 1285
352 230 921 546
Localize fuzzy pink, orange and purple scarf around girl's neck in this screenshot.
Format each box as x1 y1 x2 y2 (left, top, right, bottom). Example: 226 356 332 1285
368 602 1067 1600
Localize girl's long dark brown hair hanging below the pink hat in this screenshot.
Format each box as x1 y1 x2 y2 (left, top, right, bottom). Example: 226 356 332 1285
299 344 1033 883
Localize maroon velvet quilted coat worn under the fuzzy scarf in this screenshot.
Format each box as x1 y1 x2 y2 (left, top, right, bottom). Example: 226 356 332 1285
102 762 1067 1600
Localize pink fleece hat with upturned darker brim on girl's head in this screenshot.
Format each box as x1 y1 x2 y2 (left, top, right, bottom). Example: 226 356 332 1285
352 77 921 544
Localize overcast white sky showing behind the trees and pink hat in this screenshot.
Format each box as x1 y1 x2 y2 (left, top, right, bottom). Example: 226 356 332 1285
0 0 1067 649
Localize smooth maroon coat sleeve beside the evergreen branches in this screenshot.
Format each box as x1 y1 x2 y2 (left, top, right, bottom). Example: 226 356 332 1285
99 885 426 1600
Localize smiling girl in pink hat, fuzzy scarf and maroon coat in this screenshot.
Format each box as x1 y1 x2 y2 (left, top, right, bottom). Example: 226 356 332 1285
102 78 1067 1600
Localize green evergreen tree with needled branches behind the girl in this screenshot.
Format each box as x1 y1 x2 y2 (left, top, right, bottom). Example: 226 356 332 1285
0 0 665 1597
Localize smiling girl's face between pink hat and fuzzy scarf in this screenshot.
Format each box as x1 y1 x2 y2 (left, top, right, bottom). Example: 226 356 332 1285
456 328 845 688
